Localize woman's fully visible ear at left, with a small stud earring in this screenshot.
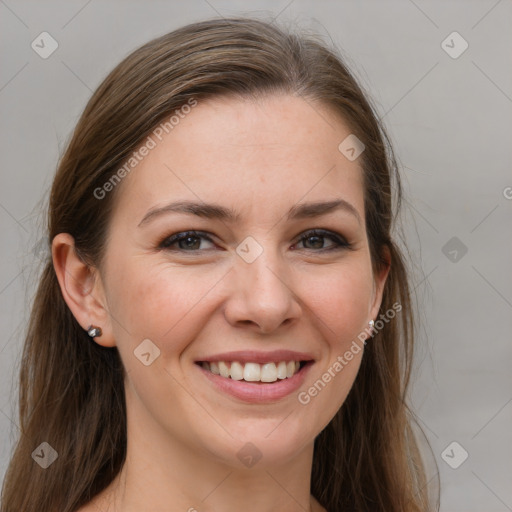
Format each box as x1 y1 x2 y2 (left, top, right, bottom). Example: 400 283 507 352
52 233 115 347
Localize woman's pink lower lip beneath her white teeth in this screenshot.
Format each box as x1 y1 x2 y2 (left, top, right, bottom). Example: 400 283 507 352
196 362 313 404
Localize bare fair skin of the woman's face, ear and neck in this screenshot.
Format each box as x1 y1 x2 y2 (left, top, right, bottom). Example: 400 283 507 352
52 95 389 512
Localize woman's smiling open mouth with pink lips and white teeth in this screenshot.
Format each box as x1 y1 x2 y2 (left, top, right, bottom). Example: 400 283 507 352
195 350 315 403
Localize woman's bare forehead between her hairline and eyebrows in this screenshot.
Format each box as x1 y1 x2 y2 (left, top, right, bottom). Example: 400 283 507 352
110 95 364 226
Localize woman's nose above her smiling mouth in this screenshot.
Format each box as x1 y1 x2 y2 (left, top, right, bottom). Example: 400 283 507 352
224 246 302 334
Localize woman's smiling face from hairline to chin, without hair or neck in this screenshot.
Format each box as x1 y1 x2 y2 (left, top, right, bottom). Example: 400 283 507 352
96 96 387 467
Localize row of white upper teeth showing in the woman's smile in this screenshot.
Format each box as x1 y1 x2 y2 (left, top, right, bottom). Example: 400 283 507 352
202 361 300 382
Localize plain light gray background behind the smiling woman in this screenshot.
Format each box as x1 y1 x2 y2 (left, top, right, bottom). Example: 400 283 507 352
0 0 512 512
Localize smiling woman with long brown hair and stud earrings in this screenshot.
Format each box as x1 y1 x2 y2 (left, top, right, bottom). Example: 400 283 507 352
1 19 438 512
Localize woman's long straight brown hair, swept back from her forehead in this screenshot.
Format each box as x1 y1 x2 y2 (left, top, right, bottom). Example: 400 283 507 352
1 18 438 512
